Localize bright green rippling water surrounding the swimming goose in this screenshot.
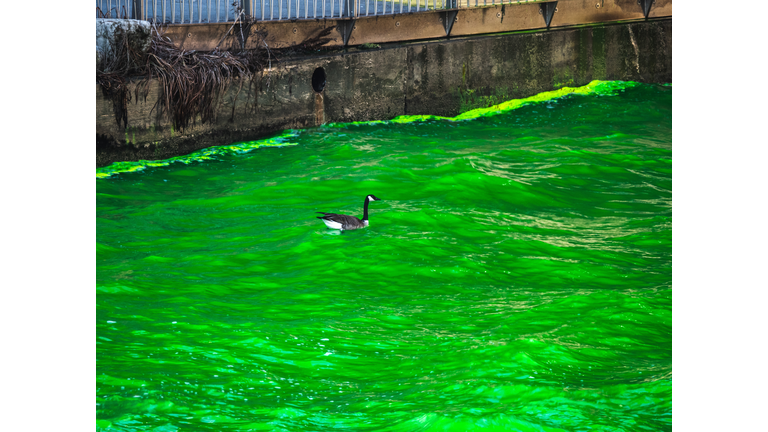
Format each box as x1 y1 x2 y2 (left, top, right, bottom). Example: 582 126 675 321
96 82 672 431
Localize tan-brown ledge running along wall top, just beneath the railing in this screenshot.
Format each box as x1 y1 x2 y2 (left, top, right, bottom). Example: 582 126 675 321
159 0 672 51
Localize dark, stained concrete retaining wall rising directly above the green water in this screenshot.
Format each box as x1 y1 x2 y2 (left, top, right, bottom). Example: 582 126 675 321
96 19 672 166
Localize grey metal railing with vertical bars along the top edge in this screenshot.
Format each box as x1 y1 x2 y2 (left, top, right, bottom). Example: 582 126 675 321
96 0 551 24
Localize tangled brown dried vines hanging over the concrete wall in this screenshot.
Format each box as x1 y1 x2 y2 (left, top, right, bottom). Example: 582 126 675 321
96 13 333 131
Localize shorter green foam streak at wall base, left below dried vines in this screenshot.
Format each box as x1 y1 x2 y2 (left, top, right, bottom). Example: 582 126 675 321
96 130 299 178
